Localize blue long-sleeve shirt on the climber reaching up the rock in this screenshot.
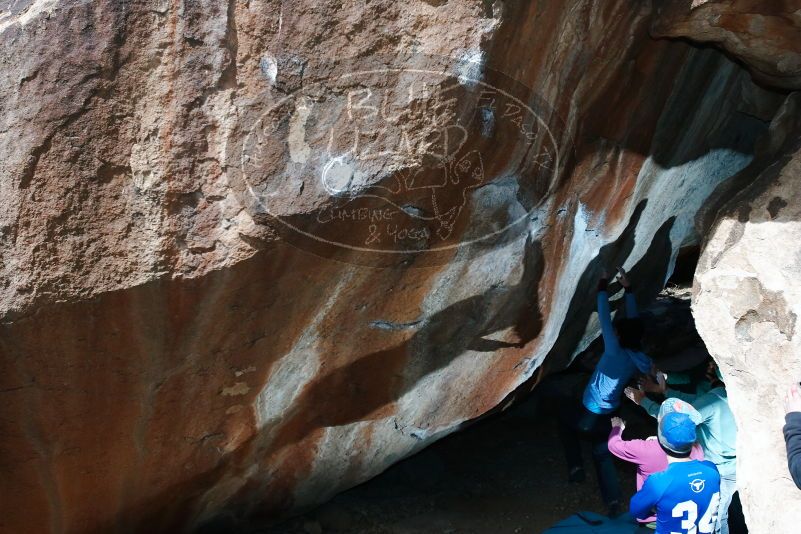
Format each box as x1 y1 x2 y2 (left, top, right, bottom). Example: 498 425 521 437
584 291 651 414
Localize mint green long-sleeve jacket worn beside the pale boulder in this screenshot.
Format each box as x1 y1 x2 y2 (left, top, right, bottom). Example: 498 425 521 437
641 387 737 478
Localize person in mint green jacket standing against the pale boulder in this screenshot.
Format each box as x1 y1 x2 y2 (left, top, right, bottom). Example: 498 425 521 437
625 364 737 534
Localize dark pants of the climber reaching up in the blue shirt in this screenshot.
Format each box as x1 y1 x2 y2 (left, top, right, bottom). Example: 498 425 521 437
559 405 621 505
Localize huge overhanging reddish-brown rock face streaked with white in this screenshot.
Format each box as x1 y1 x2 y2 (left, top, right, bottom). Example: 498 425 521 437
0 0 792 532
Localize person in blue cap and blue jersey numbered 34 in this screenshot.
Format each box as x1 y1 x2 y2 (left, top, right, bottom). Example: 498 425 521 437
629 401 720 534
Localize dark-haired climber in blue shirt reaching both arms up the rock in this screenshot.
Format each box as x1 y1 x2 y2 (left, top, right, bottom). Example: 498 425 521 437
561 268 652 517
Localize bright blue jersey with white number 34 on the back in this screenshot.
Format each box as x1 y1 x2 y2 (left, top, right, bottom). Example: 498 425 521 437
630 460 720 534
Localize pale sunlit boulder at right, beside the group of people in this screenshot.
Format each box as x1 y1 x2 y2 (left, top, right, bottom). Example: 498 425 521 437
693 94 801 532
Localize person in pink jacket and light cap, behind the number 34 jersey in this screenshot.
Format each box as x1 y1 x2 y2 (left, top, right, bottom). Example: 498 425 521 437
608 398 704 523
